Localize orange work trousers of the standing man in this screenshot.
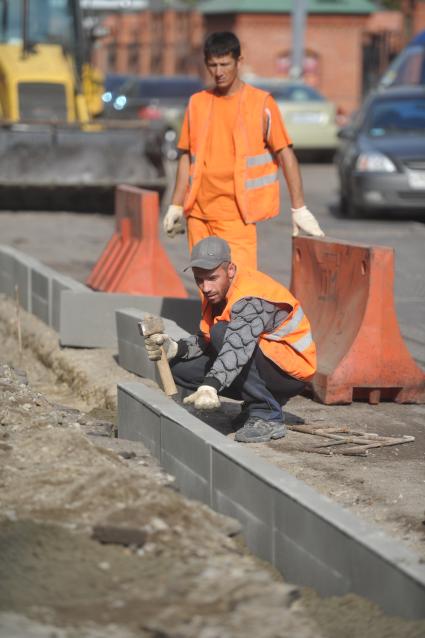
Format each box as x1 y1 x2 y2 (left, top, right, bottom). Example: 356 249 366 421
187 215 257 270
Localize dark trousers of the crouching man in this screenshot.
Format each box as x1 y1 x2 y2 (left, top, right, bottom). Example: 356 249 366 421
170 321 305 421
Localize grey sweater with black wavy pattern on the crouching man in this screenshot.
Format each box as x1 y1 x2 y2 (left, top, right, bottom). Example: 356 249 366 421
176 297 291 391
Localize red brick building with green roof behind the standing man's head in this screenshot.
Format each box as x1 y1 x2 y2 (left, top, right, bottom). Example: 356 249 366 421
200 0 375 112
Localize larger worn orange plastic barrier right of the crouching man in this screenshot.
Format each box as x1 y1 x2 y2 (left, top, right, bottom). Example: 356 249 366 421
291 237 425 404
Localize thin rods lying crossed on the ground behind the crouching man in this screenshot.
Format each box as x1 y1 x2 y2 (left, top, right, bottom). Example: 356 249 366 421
288 425 415 456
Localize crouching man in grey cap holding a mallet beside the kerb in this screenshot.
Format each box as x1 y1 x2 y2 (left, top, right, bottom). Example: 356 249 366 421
145 237 316 443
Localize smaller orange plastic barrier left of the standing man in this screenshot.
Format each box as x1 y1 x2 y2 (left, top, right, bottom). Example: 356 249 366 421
86 185 188 297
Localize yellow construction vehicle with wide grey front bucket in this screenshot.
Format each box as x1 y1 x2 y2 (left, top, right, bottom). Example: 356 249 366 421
0 0 165 211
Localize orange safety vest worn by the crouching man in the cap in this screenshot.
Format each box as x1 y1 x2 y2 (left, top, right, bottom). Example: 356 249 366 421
200 270 317 381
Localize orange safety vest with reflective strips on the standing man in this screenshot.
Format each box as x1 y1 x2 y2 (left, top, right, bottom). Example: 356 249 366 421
184 84 279 224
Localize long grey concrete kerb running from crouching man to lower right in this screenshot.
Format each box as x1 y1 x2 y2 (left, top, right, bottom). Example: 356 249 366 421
118 382 425 619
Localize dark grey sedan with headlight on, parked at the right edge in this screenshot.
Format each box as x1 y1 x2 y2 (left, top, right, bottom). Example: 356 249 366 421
335 86 425 217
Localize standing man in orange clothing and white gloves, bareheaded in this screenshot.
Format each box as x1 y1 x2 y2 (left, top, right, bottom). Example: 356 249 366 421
164 32 324 269
